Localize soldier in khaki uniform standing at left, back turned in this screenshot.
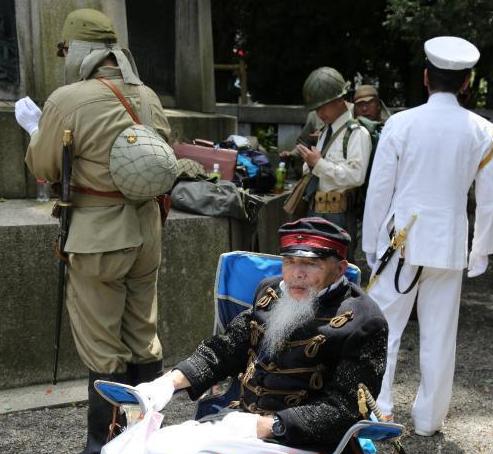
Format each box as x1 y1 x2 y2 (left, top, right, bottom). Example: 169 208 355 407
16 9 174 454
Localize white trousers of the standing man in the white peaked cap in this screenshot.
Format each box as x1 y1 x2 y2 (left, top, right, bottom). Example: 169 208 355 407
369 253 462 431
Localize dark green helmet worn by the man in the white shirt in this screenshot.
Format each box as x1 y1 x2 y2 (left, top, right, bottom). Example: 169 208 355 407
303 66 349 110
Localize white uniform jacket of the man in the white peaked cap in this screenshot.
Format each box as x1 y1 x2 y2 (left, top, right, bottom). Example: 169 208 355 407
363 93 493 270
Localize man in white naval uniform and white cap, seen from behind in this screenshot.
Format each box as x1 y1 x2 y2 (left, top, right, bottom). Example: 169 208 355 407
363 37 493 436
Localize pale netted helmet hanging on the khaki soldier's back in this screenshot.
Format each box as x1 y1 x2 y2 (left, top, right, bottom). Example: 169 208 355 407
110 125 177 200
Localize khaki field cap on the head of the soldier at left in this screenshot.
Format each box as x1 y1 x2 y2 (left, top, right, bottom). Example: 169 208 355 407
62 8 117 43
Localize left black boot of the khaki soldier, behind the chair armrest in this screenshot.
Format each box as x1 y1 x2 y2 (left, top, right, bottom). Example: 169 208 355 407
81 371 128 454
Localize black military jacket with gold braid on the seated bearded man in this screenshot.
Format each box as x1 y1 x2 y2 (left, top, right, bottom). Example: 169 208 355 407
176 277 387 450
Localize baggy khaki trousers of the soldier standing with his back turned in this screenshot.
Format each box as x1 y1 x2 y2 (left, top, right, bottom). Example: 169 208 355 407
67 207 162 373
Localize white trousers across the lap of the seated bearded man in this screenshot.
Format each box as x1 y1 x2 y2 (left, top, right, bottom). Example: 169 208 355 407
145 421 316 454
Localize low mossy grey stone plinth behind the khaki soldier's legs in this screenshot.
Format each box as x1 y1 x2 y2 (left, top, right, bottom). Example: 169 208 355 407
0 201 230 389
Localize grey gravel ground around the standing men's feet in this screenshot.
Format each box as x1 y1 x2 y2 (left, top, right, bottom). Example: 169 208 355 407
0 266 493 454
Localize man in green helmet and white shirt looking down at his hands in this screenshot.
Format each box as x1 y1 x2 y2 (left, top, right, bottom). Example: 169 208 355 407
297 67 372 260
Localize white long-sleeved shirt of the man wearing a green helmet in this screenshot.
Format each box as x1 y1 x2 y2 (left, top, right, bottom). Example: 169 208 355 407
303 110 371 192
